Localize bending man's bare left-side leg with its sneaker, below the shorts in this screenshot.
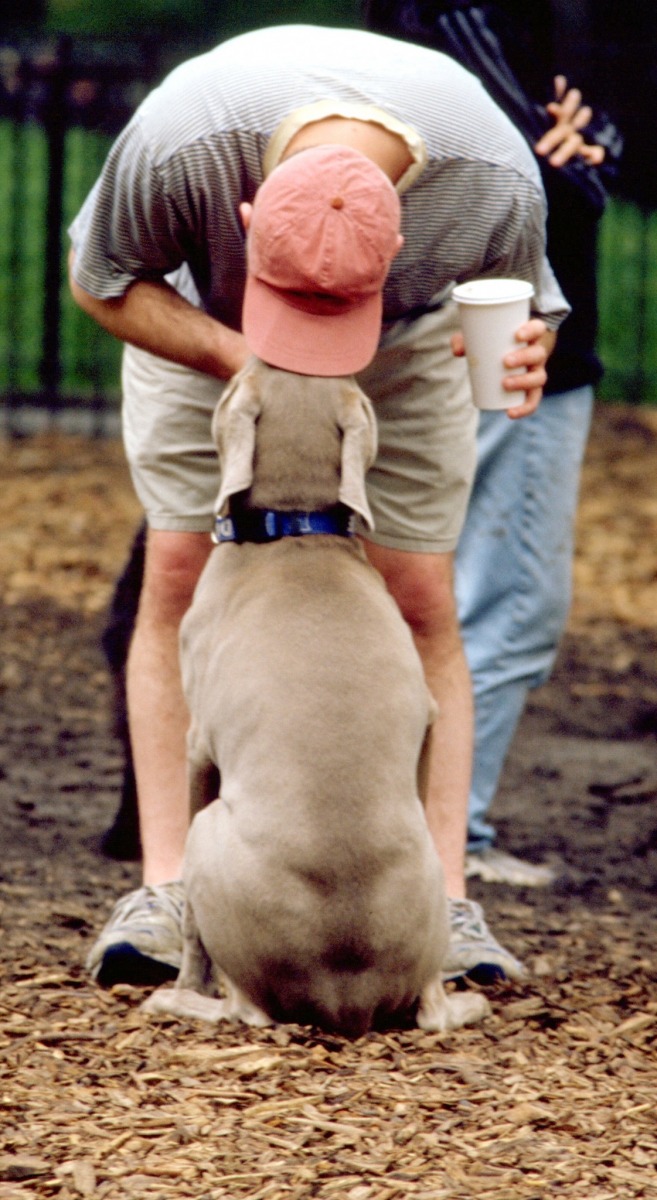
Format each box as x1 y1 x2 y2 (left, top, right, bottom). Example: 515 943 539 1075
88 530 212 986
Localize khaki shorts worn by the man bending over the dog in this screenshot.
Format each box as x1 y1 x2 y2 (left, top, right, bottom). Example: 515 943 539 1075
122 304 477 553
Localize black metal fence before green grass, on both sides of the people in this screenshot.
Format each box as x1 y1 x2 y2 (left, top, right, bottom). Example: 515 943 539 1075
0 37 657 432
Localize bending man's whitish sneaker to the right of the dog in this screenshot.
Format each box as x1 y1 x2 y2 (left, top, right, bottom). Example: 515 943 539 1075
442 900 526 984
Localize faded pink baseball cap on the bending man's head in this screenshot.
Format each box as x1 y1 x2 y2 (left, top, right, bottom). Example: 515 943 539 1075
242 145 402 376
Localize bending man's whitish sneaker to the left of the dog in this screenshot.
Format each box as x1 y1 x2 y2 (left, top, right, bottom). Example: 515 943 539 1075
86 880 185 988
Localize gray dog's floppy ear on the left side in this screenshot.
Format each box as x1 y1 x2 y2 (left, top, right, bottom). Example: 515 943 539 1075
212 365 260 515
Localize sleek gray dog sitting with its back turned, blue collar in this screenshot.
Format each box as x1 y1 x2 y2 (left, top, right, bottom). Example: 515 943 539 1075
145 359 488 1036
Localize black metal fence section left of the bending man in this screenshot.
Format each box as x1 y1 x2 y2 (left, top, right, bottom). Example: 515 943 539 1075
0 37 199 431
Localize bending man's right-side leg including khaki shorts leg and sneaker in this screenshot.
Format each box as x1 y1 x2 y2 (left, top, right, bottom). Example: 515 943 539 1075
358 304 522 977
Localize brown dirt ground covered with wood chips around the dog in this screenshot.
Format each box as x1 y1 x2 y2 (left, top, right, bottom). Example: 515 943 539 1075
0 407 657 1200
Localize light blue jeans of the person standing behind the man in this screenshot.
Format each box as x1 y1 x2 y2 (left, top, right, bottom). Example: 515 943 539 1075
456 388 593 851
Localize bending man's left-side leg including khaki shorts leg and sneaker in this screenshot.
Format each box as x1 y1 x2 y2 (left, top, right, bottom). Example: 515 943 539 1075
88 347 222 985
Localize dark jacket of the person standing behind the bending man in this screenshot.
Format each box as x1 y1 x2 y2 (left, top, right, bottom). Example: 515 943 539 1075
363 0 621 395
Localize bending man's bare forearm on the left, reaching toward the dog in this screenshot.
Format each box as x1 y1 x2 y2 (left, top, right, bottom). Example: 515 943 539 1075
68 251 248 379
